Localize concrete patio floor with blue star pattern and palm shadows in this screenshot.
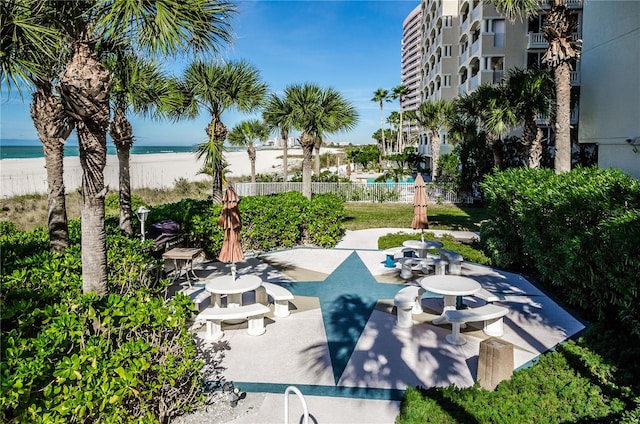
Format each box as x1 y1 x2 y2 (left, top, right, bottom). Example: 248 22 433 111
175 229 584 423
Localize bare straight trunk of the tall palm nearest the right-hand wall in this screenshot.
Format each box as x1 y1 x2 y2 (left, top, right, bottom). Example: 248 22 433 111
553 62 571 174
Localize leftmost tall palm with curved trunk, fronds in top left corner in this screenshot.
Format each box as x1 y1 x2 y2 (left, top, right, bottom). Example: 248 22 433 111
0 1 75 253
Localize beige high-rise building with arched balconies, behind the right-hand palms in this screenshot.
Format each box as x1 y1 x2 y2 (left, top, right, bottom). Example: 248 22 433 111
403 0 582 175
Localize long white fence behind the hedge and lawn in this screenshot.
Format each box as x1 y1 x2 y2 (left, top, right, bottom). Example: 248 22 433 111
233 182 473 204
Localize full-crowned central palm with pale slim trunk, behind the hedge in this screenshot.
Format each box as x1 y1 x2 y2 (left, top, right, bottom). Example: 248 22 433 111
285 83 358 199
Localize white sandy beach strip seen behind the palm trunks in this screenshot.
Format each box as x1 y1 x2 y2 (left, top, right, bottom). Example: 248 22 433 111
0 149 314 198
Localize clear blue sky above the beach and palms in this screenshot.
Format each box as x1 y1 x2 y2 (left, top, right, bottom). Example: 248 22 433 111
0 0 420 146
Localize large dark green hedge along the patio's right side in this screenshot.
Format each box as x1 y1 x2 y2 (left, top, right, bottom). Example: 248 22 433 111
480 168 640 335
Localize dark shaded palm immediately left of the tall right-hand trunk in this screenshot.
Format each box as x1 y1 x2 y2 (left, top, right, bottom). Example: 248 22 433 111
505 68 553 168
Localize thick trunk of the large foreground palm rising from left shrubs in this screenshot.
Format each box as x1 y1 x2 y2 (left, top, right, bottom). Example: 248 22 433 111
60 41 111 296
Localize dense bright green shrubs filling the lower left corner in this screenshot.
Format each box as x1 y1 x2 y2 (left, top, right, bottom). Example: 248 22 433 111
0 219 202 423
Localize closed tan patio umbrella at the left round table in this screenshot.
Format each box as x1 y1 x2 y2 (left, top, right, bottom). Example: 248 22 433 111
218 186 244 278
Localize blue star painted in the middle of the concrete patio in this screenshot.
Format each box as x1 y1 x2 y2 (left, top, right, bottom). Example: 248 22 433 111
282 251 402 384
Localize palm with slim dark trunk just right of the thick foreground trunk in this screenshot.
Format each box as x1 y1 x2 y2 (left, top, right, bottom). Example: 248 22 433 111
105 52 180 235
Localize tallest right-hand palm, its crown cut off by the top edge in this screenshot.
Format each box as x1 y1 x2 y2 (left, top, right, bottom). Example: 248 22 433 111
491 0 581 173
